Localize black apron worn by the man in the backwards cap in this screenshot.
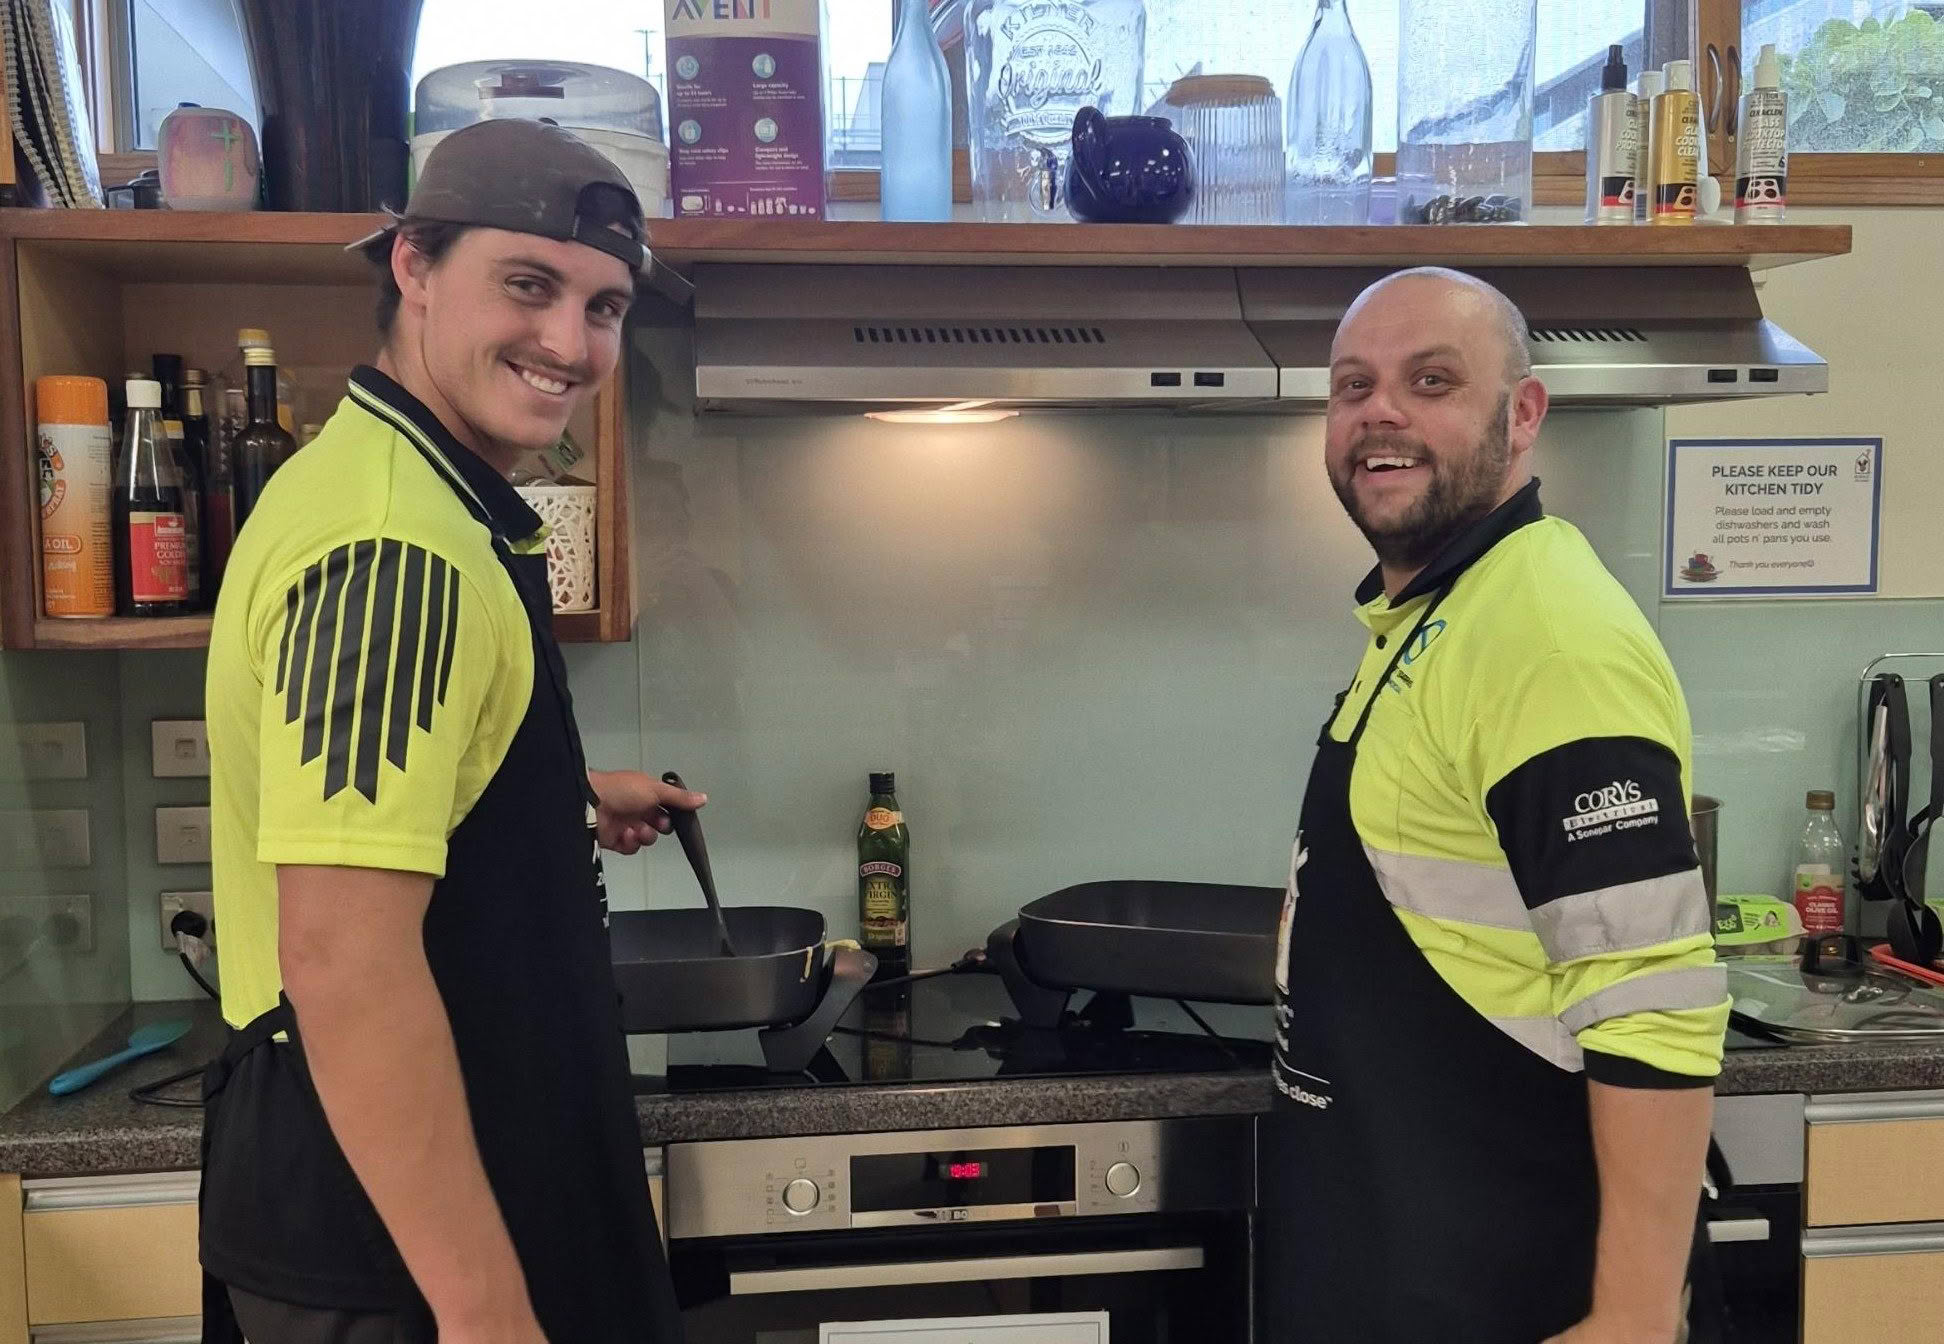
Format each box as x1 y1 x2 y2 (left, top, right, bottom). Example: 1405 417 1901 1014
202 447 682 1344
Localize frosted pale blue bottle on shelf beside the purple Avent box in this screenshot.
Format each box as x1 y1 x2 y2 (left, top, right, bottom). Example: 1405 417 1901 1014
879 0 953 220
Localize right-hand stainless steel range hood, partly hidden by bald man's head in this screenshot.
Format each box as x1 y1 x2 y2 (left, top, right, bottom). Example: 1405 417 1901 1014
1238 266 1829 407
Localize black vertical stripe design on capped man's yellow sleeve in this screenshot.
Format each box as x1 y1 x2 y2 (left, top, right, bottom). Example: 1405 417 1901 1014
276 537 459 803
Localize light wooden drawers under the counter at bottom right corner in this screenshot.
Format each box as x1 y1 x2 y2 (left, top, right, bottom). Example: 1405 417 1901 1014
1802 1091 1944 1344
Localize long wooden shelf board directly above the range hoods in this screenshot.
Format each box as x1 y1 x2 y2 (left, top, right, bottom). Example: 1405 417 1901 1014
647 220 1851 270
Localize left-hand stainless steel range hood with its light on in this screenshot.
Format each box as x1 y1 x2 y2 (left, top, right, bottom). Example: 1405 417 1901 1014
694 265 1279 410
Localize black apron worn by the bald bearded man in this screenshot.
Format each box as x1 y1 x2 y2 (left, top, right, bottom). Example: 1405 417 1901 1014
1260 585 1640 1344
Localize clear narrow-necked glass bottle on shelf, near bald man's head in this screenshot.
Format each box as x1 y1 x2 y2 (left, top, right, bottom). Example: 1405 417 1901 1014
1283 0 1371 224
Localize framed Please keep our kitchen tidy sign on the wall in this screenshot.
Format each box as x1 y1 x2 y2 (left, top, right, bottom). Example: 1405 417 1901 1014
1662 438 1884 597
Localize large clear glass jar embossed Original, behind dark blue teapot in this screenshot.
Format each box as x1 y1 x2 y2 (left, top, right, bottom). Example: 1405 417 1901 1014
964 0 1147 224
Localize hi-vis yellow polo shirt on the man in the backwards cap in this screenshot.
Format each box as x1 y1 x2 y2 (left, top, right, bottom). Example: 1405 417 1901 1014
206 368 544 1027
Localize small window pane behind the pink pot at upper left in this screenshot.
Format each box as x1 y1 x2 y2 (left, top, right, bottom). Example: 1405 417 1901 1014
115 0 260 150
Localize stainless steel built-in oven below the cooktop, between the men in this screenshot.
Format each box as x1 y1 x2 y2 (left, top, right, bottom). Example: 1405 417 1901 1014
667 1116 1254 1344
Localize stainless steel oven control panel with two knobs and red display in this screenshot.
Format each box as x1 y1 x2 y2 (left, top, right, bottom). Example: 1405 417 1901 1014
667 1116 1254 1239
